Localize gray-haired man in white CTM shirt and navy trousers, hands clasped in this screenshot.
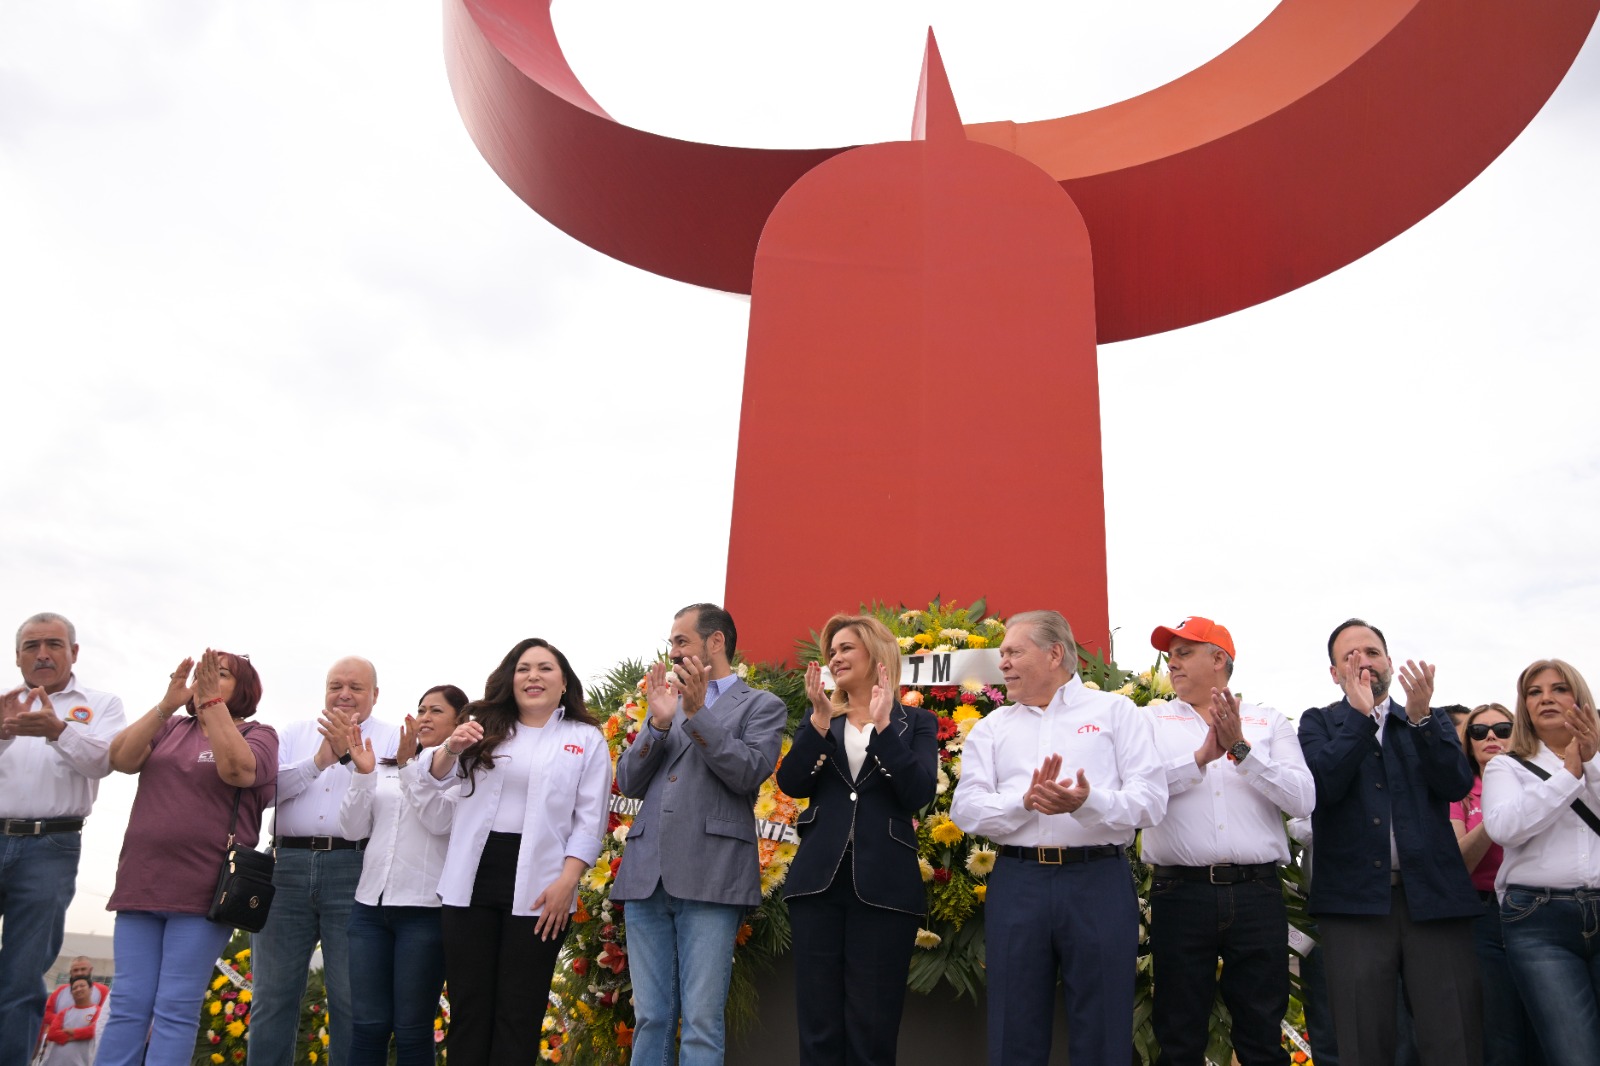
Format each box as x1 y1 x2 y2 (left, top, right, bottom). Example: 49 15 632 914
950 611 1166 1066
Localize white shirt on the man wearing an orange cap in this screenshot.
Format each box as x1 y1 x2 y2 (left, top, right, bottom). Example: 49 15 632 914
1139 699 1317 866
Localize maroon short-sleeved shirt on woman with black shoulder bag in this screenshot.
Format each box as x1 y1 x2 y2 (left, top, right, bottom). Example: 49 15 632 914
106 714 278 914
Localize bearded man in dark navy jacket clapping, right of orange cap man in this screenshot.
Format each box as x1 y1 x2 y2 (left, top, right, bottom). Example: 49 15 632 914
1299 618 1483 1066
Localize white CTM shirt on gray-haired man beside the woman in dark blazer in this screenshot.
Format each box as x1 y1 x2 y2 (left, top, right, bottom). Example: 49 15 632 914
950 677 1166 848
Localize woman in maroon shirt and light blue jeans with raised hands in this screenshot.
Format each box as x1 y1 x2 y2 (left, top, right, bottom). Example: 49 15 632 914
94 648 278 1066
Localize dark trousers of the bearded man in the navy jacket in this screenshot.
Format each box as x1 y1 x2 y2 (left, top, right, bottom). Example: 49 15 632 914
1317 885 1483 1066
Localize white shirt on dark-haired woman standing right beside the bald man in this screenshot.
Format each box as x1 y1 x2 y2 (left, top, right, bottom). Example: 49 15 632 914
339 749 456 908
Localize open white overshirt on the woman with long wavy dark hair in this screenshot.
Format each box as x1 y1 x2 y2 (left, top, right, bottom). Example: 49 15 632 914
426 711 611 916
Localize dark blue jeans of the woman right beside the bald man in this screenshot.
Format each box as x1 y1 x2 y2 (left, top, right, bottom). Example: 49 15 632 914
347 900 445 1066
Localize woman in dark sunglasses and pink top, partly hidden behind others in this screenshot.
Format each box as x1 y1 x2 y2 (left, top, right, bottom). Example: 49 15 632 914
1450 703 1544 1066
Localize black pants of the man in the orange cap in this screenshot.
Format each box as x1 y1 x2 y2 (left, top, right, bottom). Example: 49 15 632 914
1150 877 1290 1066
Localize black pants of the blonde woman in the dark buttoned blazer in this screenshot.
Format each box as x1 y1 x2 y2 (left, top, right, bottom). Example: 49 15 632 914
789 852 922 1066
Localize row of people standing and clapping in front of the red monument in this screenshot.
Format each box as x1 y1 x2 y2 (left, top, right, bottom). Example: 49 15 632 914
0 603 1600 1066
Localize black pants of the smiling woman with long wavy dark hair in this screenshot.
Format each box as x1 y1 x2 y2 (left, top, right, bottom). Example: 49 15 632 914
440 832 571 1066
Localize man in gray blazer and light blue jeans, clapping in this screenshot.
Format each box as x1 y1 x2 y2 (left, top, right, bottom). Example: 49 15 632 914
611 603 789 1066
